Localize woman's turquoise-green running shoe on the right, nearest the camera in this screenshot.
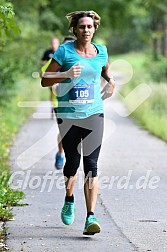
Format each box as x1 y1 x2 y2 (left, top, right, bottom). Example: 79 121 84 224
83 215 100 235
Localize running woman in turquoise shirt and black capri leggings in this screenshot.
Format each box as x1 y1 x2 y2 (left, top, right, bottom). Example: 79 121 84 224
41 11 115 235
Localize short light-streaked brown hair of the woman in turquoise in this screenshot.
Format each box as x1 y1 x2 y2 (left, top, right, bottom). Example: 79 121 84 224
66 11 101 36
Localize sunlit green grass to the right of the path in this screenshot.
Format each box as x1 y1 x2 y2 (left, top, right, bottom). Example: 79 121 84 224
110 53 167 142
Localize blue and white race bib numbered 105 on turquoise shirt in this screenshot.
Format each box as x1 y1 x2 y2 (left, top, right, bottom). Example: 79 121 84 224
69 84 94 103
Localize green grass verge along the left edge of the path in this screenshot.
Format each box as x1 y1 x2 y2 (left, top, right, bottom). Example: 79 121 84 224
0 77 49 221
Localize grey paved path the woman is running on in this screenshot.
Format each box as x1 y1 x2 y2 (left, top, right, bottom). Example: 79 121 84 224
7 93 167 252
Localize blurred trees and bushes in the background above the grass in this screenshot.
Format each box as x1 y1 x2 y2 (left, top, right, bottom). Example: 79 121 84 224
0 0 167 104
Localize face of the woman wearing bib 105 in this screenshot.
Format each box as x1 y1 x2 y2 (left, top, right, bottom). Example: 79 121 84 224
76 17 95 41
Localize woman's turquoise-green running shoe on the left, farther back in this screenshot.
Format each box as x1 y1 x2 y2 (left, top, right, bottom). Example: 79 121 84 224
61 201 75 225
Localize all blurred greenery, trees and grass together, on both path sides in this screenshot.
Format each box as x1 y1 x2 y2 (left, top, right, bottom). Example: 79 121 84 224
0 0 167 219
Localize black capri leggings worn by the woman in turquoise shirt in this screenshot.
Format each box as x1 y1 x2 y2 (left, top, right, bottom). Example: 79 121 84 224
57 114 104 178
